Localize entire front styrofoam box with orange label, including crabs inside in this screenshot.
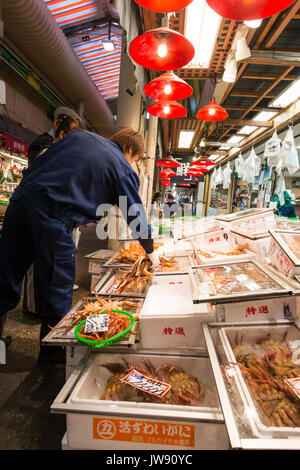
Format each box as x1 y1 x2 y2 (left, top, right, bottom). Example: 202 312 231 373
51 350 228 450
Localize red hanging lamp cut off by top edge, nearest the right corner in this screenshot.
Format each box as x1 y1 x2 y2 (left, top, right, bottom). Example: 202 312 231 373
206 0 295 21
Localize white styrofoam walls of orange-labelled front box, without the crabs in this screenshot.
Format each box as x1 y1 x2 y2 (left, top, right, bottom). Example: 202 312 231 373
63 353 229 450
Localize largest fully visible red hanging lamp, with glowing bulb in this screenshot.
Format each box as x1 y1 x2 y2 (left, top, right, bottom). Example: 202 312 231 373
129 26 195 71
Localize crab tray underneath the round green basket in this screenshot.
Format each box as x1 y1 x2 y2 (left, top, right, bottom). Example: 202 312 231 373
42 296 144 347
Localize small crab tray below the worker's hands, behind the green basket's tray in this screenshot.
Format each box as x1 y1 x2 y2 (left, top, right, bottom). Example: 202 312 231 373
94 270 152 298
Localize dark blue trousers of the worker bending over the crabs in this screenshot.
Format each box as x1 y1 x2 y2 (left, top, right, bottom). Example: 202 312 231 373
0 195 76 326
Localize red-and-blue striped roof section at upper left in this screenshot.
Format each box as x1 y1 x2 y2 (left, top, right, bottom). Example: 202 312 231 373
44 0 123 101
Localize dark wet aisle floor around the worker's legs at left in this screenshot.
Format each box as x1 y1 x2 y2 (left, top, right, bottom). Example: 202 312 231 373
0 225 105 450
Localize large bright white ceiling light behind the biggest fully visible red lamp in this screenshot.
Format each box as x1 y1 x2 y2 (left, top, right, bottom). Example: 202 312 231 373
185 0 222 69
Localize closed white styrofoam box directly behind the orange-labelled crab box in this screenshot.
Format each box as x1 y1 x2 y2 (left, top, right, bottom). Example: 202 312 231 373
139 274 215 349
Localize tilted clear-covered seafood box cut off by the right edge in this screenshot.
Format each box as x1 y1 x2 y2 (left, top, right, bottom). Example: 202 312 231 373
269 230 300 277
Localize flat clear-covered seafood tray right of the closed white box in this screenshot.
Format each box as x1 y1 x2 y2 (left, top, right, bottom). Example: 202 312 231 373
190 261 295 304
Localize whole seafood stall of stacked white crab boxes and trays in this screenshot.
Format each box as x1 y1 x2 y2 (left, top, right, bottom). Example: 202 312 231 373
44 210 300 450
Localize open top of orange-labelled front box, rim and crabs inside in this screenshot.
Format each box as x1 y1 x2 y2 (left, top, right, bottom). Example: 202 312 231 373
67 353 220 420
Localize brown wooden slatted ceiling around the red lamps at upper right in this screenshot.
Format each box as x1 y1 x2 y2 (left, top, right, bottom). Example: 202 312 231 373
142 0 300 162
